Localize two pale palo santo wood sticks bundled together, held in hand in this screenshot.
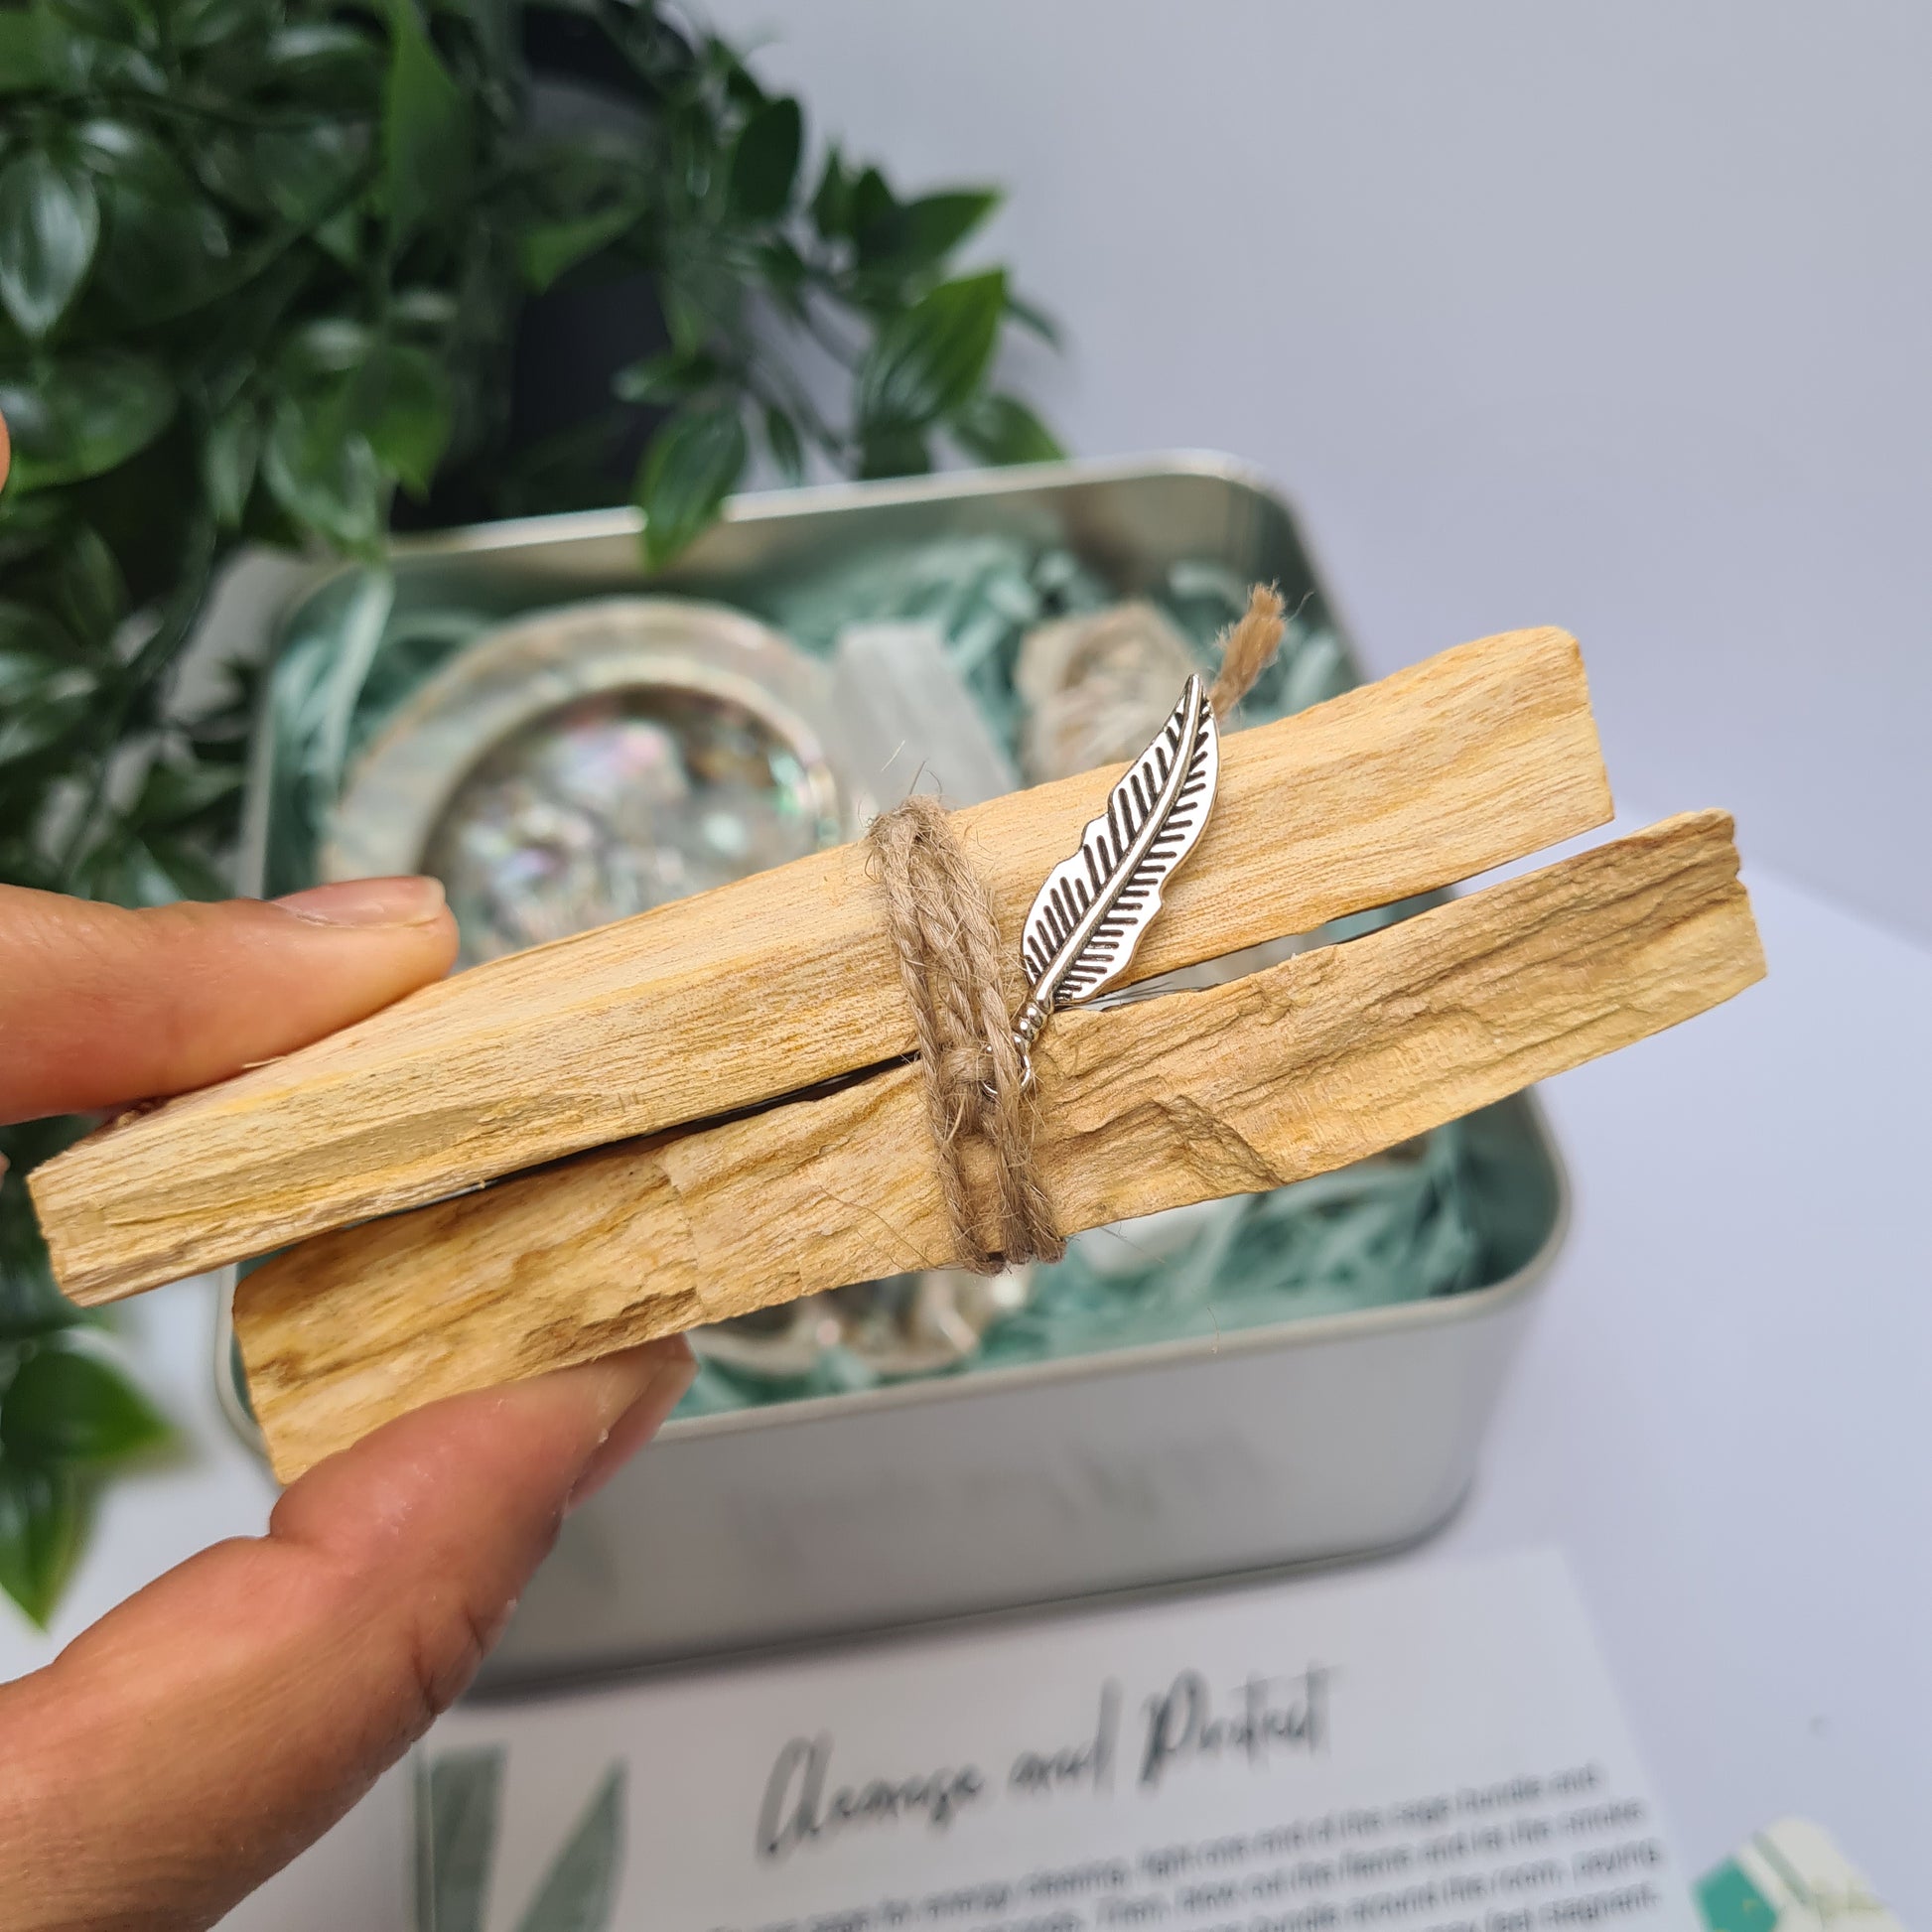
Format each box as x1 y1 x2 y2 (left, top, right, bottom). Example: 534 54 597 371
31 629 1764 1480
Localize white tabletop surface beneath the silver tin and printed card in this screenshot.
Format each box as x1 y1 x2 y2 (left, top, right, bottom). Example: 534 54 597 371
0 841 1932 1932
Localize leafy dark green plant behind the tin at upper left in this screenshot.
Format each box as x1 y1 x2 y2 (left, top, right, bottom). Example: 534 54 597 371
0 0 1058 1617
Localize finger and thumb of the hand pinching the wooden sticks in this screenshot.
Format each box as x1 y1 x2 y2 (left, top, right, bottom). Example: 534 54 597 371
0 879 692 1932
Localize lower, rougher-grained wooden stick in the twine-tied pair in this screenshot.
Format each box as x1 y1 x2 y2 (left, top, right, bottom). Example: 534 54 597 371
235 811 1764 1480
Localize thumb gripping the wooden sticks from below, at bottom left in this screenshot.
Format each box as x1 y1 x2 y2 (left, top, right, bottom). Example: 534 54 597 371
0 1341 692 1932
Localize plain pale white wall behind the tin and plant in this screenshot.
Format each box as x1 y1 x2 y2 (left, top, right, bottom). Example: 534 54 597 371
709 0 1932 937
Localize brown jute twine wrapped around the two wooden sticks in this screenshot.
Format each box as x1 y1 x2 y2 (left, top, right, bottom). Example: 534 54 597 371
870 586 1283 1275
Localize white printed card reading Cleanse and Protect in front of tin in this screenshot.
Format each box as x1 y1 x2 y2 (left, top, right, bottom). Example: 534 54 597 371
417 1552 1697 1932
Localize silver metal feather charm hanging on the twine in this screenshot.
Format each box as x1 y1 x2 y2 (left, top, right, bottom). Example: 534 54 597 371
1013 674 1221 1053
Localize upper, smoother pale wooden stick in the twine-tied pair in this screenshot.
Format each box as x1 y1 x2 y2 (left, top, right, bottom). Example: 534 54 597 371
29 629 1609 1305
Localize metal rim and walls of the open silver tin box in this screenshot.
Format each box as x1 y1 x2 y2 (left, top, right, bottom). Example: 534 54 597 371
225 456 1565 1687
